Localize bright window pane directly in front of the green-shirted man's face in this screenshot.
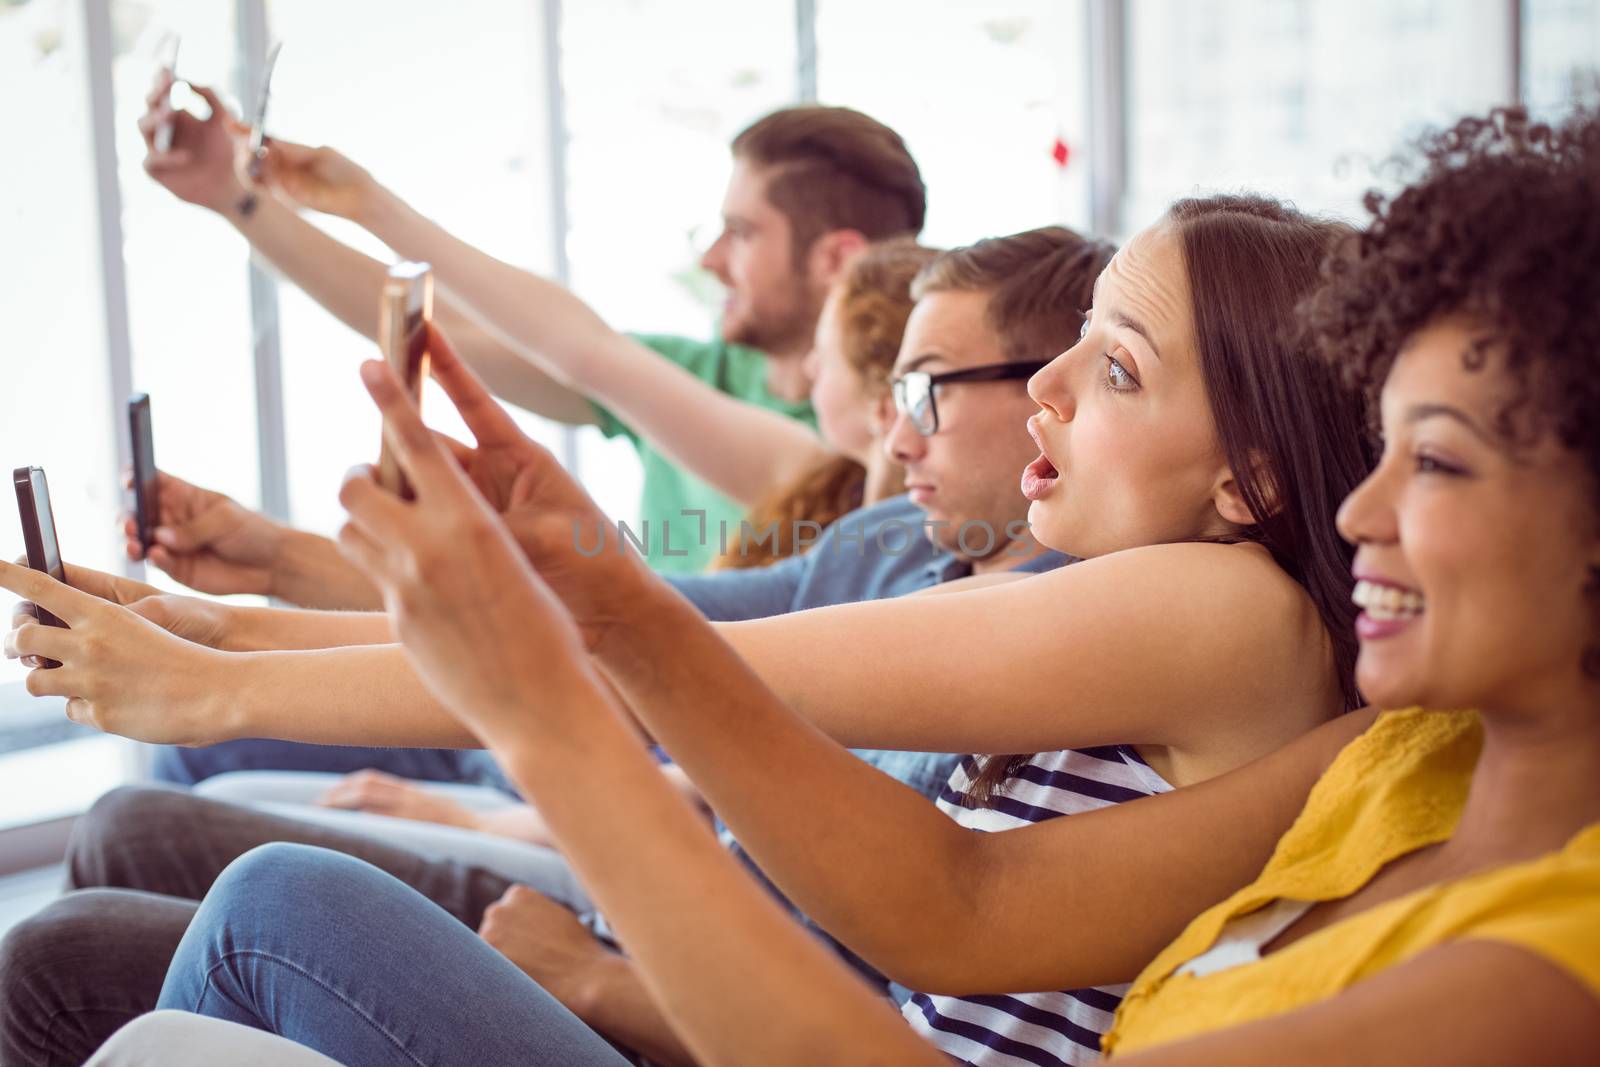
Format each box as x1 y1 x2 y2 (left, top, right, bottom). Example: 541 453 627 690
560 0 797 522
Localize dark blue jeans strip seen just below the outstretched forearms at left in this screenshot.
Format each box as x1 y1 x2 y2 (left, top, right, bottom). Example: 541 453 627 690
150 741 517 797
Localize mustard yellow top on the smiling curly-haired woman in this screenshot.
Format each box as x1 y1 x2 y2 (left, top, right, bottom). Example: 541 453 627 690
1101 709 1600 1056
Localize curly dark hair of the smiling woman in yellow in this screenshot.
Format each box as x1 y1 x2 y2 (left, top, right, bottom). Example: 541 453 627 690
1304 107 1600 677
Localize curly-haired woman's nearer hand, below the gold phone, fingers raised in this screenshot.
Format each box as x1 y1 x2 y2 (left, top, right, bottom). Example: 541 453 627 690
339 362 598 750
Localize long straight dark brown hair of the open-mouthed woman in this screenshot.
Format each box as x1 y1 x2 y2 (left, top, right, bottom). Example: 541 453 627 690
968 195 1374 806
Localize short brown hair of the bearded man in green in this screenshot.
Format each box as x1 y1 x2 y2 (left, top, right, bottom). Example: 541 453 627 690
733 104 928 262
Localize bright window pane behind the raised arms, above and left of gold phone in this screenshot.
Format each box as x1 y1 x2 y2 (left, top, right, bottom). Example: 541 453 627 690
267 0 558 533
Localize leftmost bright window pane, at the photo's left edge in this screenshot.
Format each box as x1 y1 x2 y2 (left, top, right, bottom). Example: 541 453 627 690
0 0 122 825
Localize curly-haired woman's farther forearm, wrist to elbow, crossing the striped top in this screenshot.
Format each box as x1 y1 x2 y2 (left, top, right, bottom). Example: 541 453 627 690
602 585 979 977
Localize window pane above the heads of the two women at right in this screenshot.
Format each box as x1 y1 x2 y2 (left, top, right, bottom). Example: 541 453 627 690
1123 0 1514 232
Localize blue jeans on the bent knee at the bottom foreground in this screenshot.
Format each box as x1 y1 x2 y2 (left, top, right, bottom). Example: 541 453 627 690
158 845 629 1067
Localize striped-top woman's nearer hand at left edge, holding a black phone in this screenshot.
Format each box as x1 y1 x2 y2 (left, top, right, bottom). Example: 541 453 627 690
0 563 229 744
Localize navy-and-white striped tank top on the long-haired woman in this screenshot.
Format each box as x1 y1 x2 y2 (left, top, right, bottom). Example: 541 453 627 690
901 745 1171 1067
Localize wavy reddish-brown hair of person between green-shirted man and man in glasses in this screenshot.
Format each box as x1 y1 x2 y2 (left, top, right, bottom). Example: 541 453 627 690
714 238 939 569
